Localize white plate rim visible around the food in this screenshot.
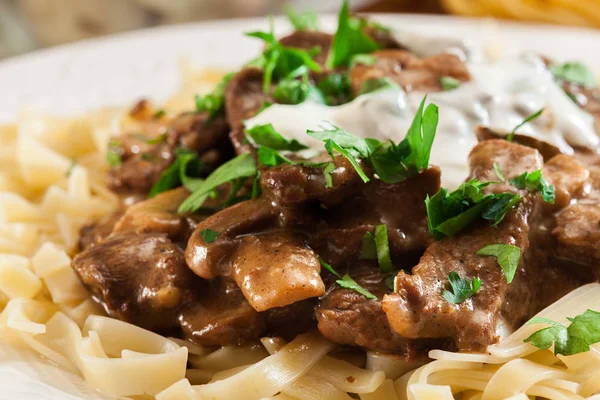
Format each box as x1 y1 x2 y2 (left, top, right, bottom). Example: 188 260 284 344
0 15 600 400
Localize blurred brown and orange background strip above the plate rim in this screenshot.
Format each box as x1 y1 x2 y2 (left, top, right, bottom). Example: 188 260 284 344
0 0 600 58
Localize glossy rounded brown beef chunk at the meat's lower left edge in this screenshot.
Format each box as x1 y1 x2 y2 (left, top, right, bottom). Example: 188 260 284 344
73 233 195 330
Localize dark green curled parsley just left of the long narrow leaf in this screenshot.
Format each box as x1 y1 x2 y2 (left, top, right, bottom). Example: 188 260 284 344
148 149 202 197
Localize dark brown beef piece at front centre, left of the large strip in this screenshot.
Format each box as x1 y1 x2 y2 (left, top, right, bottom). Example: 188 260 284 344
315 261 452 360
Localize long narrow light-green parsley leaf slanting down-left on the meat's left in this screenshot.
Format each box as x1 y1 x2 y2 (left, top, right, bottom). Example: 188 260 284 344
178 154 257 213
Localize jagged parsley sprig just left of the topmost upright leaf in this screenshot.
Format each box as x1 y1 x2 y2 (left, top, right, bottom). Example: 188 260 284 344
246 19 321 93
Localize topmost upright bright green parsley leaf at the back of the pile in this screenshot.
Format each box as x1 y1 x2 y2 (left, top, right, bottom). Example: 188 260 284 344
326 0 381 69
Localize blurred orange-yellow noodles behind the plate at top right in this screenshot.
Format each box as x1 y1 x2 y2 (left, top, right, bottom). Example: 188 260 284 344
442 0 600 27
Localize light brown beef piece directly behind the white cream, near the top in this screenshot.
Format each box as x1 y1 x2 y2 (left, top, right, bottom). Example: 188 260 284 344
350 50 471 95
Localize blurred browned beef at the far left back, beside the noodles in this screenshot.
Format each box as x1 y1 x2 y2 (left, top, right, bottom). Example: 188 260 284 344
109 109 233 195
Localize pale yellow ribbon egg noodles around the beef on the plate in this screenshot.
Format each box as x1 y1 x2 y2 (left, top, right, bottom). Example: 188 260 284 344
0 69 600 400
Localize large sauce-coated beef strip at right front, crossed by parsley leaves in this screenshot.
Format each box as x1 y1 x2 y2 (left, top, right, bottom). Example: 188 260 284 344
383 140 542 350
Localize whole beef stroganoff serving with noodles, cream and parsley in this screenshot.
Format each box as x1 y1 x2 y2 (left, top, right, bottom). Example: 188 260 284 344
0 2 600 400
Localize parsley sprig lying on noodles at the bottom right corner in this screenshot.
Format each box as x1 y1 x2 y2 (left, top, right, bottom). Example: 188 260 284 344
524 310 600 356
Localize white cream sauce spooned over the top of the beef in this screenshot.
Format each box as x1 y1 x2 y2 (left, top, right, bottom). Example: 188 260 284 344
246 35 599 189
